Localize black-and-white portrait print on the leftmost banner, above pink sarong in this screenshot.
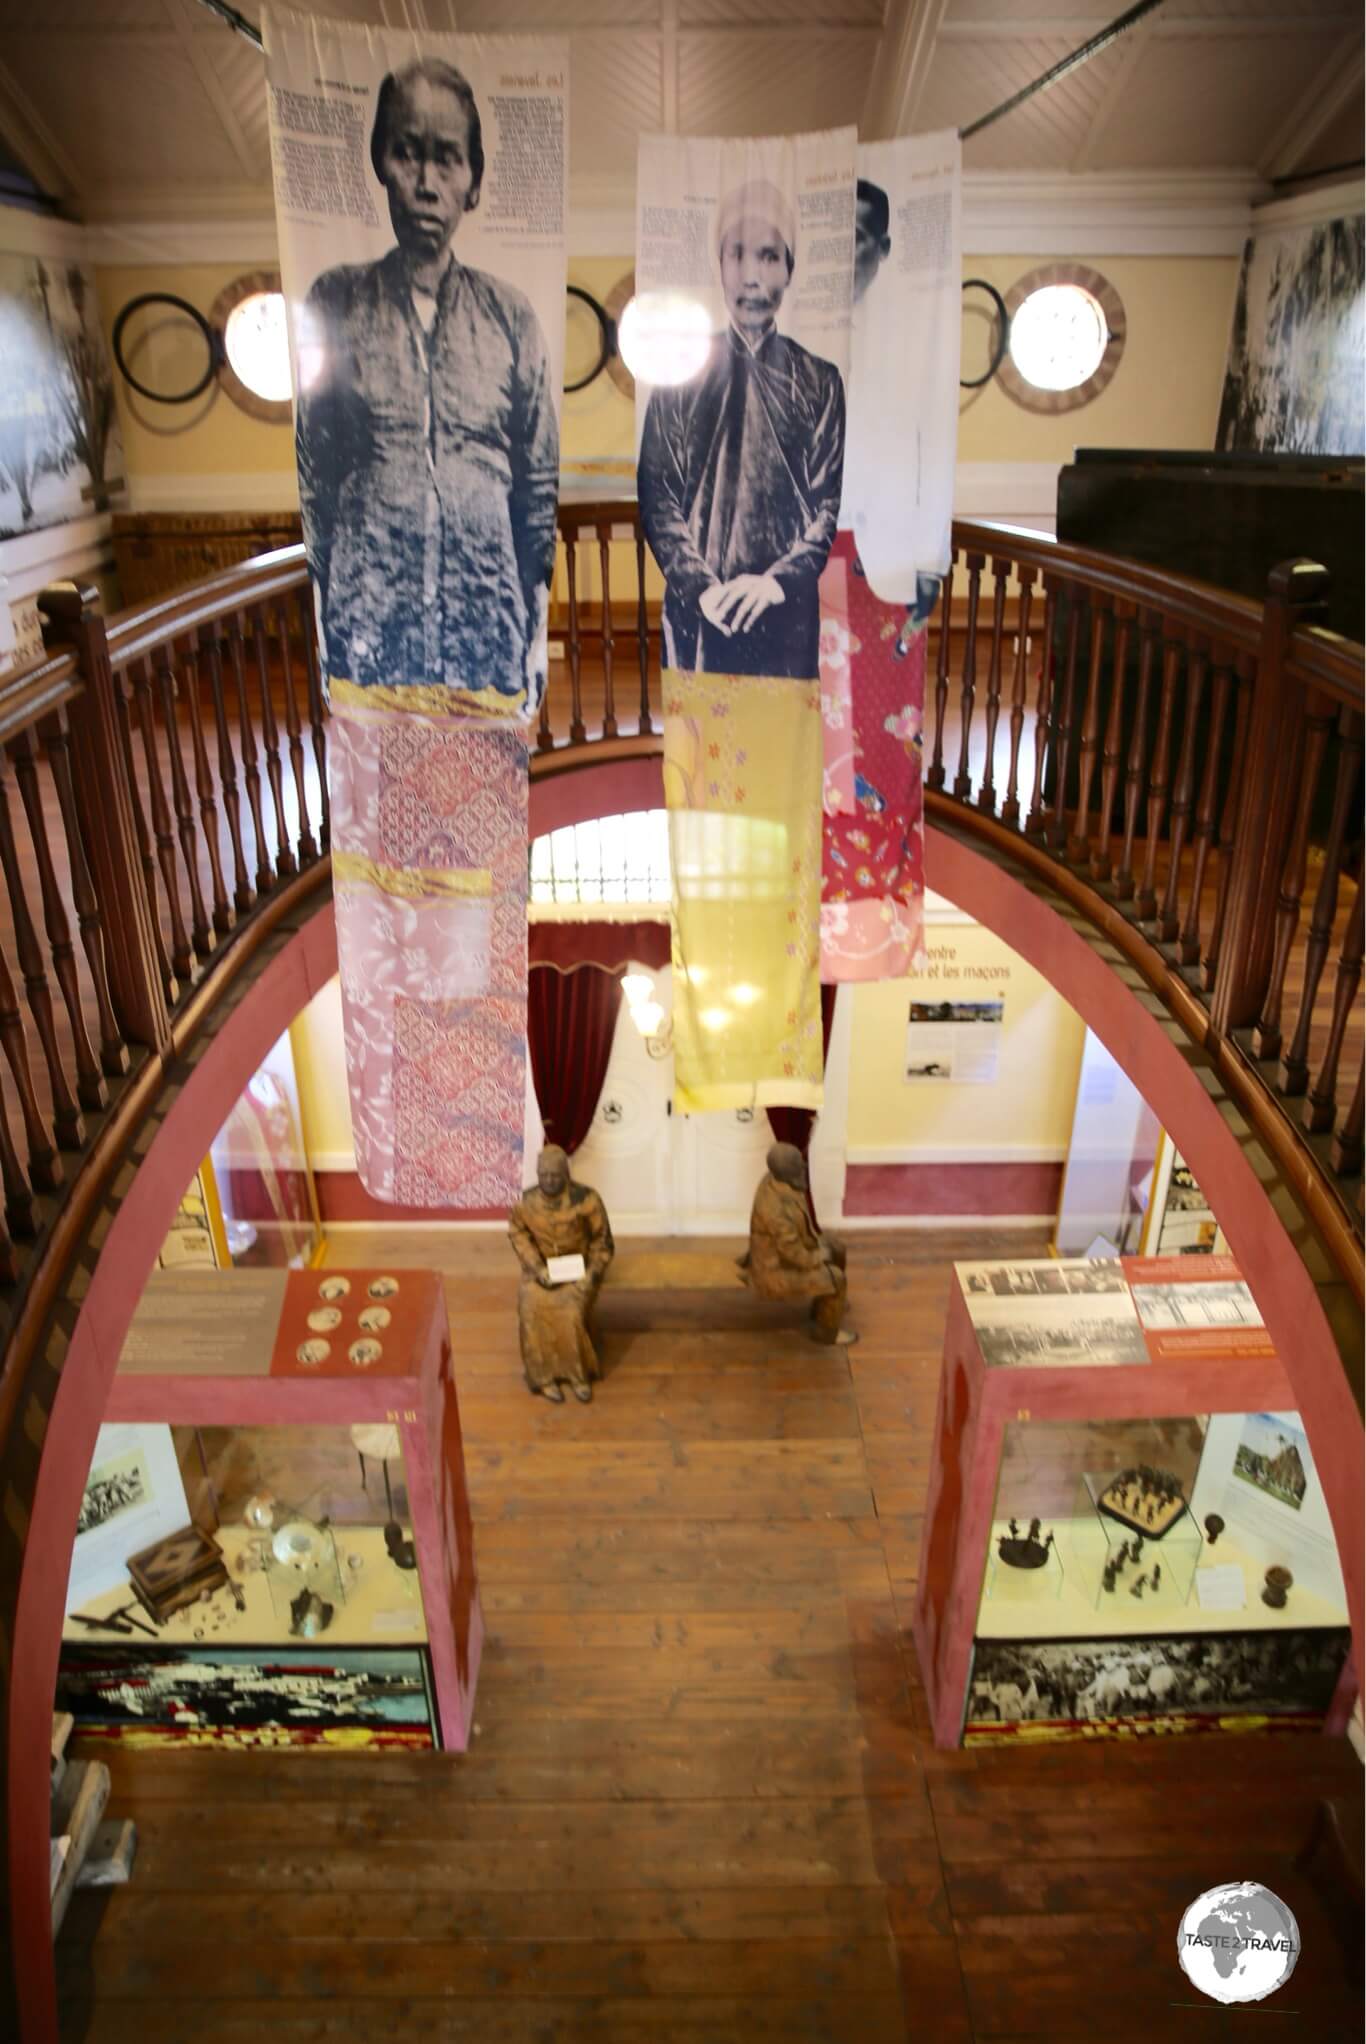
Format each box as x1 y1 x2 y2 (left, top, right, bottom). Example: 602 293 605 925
263 22 564 715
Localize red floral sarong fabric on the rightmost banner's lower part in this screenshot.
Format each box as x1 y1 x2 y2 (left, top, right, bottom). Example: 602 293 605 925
820 531 939 983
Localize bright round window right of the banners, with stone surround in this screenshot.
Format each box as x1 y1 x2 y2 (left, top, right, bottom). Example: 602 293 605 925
1000 264 1125 413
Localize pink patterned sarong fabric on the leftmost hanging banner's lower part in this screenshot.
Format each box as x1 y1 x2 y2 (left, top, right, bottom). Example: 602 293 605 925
327 707 528 1210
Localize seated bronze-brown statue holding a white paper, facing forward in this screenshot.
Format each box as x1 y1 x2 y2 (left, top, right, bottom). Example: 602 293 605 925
507 1143 616 1404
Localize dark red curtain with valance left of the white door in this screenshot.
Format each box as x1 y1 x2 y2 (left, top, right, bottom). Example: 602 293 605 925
526 922 669 1157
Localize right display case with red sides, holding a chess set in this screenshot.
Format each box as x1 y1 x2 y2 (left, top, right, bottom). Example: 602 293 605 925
914 1257 1350 1746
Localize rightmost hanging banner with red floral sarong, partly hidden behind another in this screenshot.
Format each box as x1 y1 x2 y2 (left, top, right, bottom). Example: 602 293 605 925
820 131 961 981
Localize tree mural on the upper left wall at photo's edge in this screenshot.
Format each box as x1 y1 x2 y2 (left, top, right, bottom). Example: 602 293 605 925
0 253 123 540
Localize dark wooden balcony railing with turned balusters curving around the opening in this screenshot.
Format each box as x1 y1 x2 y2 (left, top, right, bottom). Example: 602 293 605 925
0 501 1364 1332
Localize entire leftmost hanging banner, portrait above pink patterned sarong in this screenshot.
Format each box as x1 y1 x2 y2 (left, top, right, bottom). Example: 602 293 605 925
262 6 568 1208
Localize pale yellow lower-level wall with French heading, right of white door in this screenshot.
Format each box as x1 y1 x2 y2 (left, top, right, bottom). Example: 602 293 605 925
849 924 1086 1163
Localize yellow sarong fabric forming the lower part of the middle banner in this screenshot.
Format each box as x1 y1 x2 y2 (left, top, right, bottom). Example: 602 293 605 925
665 668 822 1112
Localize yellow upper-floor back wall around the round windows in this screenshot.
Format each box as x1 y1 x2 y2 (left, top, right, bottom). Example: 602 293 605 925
98 256 1237 509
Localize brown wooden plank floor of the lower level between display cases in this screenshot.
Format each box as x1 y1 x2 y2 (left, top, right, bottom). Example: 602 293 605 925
59 1228 1362 2044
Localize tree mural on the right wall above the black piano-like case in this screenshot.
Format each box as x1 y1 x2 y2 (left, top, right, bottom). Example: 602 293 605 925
1217 213 1366 454
